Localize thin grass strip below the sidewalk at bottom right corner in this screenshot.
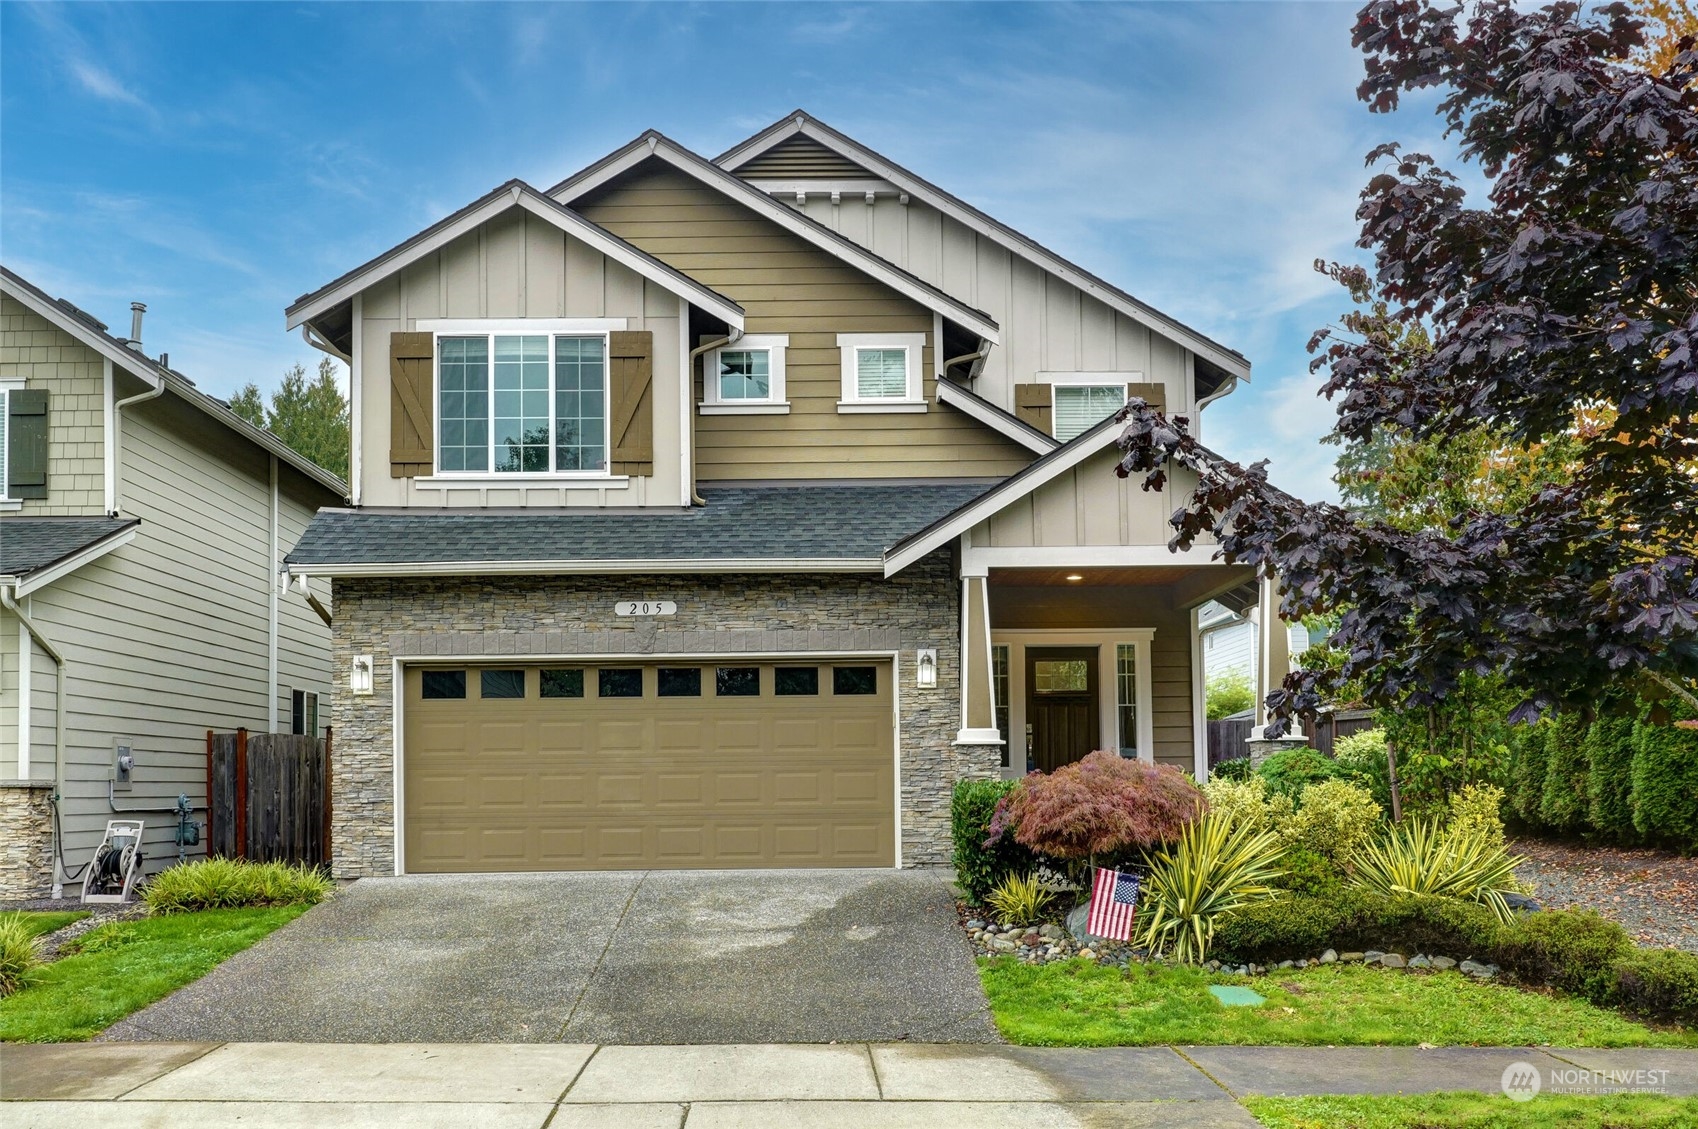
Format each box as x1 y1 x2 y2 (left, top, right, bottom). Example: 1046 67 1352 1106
1245 1093 1698 1129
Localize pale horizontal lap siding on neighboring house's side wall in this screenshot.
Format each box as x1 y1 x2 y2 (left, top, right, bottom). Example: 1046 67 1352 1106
0 396 338 873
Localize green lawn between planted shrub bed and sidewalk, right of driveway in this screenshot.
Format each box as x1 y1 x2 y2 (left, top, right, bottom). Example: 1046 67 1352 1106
980 958 1698 1048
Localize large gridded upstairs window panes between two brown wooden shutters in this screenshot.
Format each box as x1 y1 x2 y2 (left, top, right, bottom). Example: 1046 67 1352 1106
436 333 608 475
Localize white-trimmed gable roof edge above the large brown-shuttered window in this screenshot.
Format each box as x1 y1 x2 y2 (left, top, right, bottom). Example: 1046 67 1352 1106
284 180 742 329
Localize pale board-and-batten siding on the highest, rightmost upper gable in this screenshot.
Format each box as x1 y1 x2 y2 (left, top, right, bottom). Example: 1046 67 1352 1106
773 192 1195 419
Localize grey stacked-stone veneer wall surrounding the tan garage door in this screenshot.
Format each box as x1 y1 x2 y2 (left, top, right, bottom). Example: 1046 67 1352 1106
331 550 1000 878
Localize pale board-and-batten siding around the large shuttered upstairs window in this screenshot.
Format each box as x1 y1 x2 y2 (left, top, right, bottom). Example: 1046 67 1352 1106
357 211 688 506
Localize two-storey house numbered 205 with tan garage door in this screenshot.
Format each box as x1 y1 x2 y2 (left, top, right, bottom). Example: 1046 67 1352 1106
287 112 1297 878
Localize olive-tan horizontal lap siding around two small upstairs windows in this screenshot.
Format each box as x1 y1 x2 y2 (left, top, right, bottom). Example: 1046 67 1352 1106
574 161 1032 482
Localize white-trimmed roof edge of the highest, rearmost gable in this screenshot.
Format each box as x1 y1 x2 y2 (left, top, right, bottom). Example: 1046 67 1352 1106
713 110 1250 380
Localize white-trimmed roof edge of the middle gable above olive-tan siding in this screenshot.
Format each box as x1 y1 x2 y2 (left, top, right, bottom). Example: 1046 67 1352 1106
548 129 1002 345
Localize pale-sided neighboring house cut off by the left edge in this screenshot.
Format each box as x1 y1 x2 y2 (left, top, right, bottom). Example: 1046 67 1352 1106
0 268 346 898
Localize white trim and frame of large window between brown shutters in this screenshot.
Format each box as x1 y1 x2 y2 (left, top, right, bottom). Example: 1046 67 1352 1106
431 327 628 487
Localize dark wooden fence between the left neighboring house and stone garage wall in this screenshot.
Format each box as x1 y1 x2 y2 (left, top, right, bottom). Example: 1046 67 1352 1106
207 727 331 866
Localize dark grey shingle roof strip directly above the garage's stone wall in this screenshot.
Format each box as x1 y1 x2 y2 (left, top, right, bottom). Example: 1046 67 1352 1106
289 482 992 567
